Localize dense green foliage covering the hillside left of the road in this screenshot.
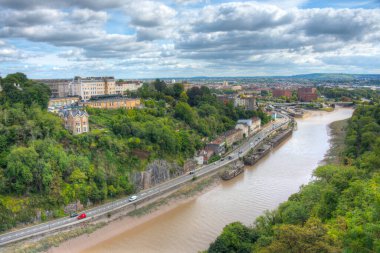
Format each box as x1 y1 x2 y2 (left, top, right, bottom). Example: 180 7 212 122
0 73 269 231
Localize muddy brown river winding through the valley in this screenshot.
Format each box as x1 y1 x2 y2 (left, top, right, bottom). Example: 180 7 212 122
52 108 353 253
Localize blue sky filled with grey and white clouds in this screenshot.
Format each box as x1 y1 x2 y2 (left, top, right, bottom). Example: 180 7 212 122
0 0 380 78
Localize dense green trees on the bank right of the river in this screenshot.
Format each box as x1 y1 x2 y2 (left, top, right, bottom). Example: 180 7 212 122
208 105 380 253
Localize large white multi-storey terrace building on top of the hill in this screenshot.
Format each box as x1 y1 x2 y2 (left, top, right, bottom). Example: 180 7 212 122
70 76 116 100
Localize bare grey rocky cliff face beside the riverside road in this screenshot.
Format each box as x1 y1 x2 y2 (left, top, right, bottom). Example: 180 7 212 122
133 160 185 190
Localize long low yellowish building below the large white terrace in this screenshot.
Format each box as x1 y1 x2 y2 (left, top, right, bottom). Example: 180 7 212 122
79 96 140 109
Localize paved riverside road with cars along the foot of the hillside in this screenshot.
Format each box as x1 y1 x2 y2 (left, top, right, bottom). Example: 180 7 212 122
0 114 290 246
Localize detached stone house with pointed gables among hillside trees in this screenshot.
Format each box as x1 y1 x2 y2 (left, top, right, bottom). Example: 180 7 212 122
60 110 89 135
